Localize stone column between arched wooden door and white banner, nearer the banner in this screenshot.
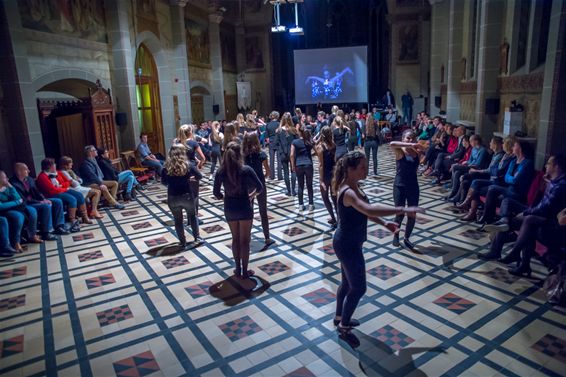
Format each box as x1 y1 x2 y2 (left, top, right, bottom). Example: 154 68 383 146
208 13 226 119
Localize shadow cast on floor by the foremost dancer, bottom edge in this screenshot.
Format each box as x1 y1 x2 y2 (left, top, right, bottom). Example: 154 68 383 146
340 330 446 377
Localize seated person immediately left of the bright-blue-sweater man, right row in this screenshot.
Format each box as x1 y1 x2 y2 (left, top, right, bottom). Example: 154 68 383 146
456 137 515 213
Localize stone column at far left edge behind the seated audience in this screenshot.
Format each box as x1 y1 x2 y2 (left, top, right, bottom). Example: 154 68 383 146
0 1 45 172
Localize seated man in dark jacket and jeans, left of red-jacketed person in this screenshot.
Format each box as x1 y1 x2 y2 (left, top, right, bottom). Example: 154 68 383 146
10 162 69 241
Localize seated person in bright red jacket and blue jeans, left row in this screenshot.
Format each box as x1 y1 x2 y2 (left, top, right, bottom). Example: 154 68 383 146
35 158 92 233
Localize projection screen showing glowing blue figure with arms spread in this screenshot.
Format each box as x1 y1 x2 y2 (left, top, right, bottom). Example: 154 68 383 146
294 46 367 104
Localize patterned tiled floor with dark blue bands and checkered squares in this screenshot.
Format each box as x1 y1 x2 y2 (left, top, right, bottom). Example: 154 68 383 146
0 146 566 376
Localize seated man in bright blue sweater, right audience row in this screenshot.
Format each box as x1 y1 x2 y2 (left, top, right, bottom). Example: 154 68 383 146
478 141 535 224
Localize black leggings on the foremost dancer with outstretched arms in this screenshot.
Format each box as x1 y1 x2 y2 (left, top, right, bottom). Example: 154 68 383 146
333 239 367 325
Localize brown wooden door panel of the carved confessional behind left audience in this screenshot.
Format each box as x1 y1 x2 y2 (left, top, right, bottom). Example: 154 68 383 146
57 114 87 166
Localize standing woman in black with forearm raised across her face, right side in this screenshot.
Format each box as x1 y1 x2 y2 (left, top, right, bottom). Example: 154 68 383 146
389 130 422 250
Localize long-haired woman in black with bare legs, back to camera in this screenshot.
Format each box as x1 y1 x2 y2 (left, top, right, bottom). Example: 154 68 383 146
213 142 263 279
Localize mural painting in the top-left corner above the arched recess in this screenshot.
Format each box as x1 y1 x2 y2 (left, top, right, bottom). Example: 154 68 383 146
18 0 108 43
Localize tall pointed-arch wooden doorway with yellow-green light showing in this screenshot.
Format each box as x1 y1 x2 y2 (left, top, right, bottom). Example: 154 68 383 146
136 43 165 154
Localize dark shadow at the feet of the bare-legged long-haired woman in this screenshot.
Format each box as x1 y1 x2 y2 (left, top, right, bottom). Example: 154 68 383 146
208 275 271 306
